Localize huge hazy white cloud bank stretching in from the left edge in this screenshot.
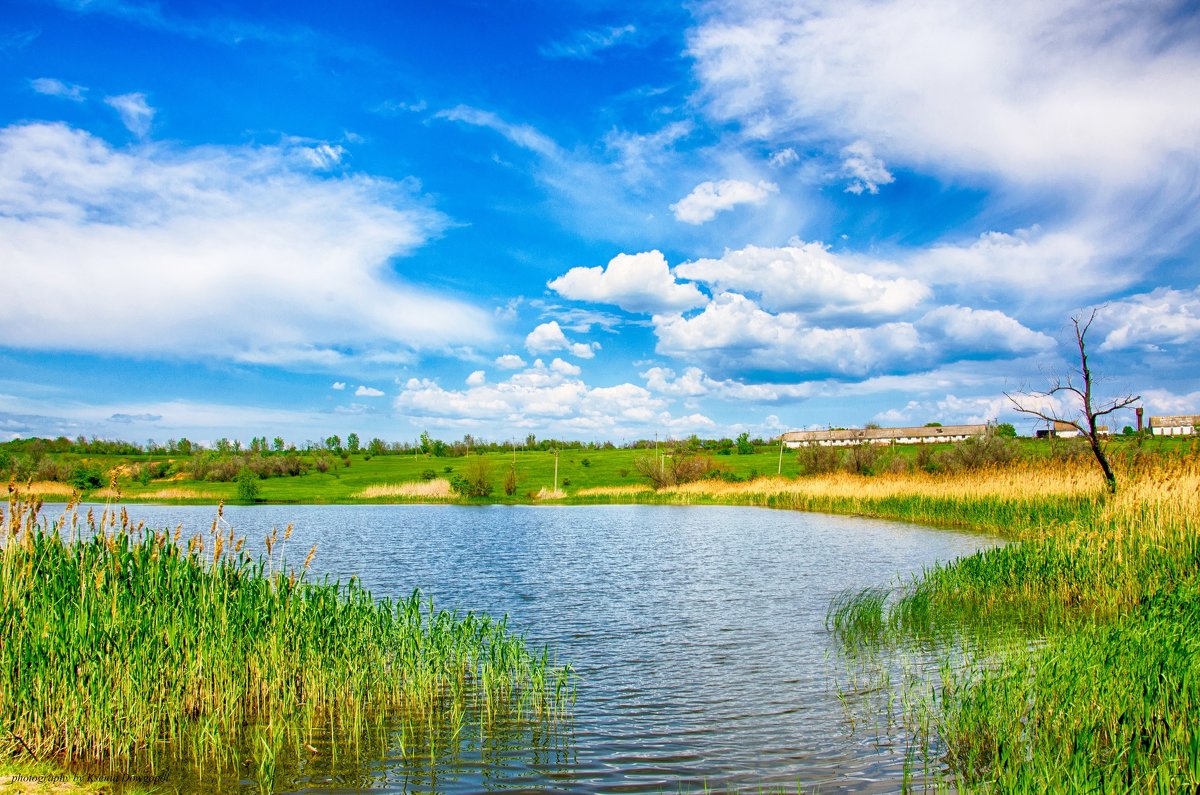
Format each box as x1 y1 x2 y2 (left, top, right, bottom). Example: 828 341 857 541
0 124 493 367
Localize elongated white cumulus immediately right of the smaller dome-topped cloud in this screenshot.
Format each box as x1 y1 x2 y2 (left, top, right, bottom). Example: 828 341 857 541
676 241 931 317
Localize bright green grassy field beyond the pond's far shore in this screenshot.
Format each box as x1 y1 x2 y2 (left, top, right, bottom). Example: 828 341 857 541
7 437 1189 503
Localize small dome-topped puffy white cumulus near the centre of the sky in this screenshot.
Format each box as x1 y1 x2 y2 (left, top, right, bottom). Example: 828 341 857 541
546 251 708 313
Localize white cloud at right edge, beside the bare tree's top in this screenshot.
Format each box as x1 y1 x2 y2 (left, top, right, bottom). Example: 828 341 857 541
1097 287 1200 351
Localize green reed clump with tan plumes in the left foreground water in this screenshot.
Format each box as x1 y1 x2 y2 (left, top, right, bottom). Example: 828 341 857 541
0 492 572 791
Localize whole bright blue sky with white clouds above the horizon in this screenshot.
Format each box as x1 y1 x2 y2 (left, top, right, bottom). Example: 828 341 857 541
0 0 1200 442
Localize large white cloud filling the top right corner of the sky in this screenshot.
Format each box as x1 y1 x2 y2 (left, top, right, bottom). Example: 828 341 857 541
689 0 1200 184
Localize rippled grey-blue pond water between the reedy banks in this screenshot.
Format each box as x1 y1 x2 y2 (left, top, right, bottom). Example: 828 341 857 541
72 506 997 793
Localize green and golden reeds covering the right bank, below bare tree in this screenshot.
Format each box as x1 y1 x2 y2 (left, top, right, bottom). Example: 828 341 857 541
829 454 1200 793
